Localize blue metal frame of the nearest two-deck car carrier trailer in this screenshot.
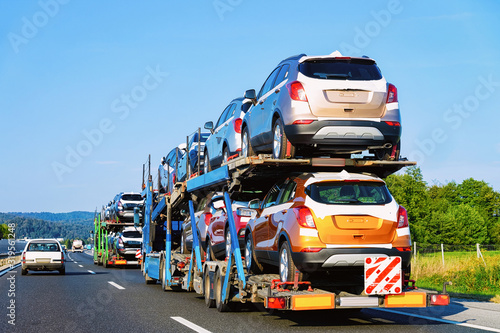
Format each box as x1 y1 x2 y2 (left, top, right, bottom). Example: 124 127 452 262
138 155 450 312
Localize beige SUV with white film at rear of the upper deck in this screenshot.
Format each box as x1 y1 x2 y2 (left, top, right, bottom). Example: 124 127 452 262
241 51 401 160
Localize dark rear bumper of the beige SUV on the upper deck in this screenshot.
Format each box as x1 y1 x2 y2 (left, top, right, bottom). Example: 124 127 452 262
285 120 401 150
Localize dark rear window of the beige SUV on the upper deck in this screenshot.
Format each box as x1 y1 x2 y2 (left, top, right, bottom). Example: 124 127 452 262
299 59 382 81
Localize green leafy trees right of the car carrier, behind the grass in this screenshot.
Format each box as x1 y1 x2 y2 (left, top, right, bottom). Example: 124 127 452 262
385 167 500 245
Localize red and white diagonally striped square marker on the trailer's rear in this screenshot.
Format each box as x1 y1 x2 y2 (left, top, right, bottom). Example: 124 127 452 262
365 257 402 295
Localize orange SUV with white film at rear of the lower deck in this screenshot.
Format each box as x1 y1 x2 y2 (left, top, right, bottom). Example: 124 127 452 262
245 171 411 283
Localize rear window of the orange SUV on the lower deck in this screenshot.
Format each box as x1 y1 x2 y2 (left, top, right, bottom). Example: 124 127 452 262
306 181 392 205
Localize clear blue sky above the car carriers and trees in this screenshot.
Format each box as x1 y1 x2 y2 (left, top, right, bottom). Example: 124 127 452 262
0 0 500 212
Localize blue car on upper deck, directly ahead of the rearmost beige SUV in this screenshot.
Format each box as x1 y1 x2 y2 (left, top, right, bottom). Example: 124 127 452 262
203 97 249 173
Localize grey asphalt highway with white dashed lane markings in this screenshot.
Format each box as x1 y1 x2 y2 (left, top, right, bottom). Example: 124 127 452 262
0 253 500 333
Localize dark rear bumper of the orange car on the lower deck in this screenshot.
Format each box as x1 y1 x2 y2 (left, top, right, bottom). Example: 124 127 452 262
292 248 411 273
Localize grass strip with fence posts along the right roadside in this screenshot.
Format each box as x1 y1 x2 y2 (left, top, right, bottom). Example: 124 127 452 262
412 251 500 300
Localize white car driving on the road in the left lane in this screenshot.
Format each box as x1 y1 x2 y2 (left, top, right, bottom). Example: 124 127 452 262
21 239 66 275
